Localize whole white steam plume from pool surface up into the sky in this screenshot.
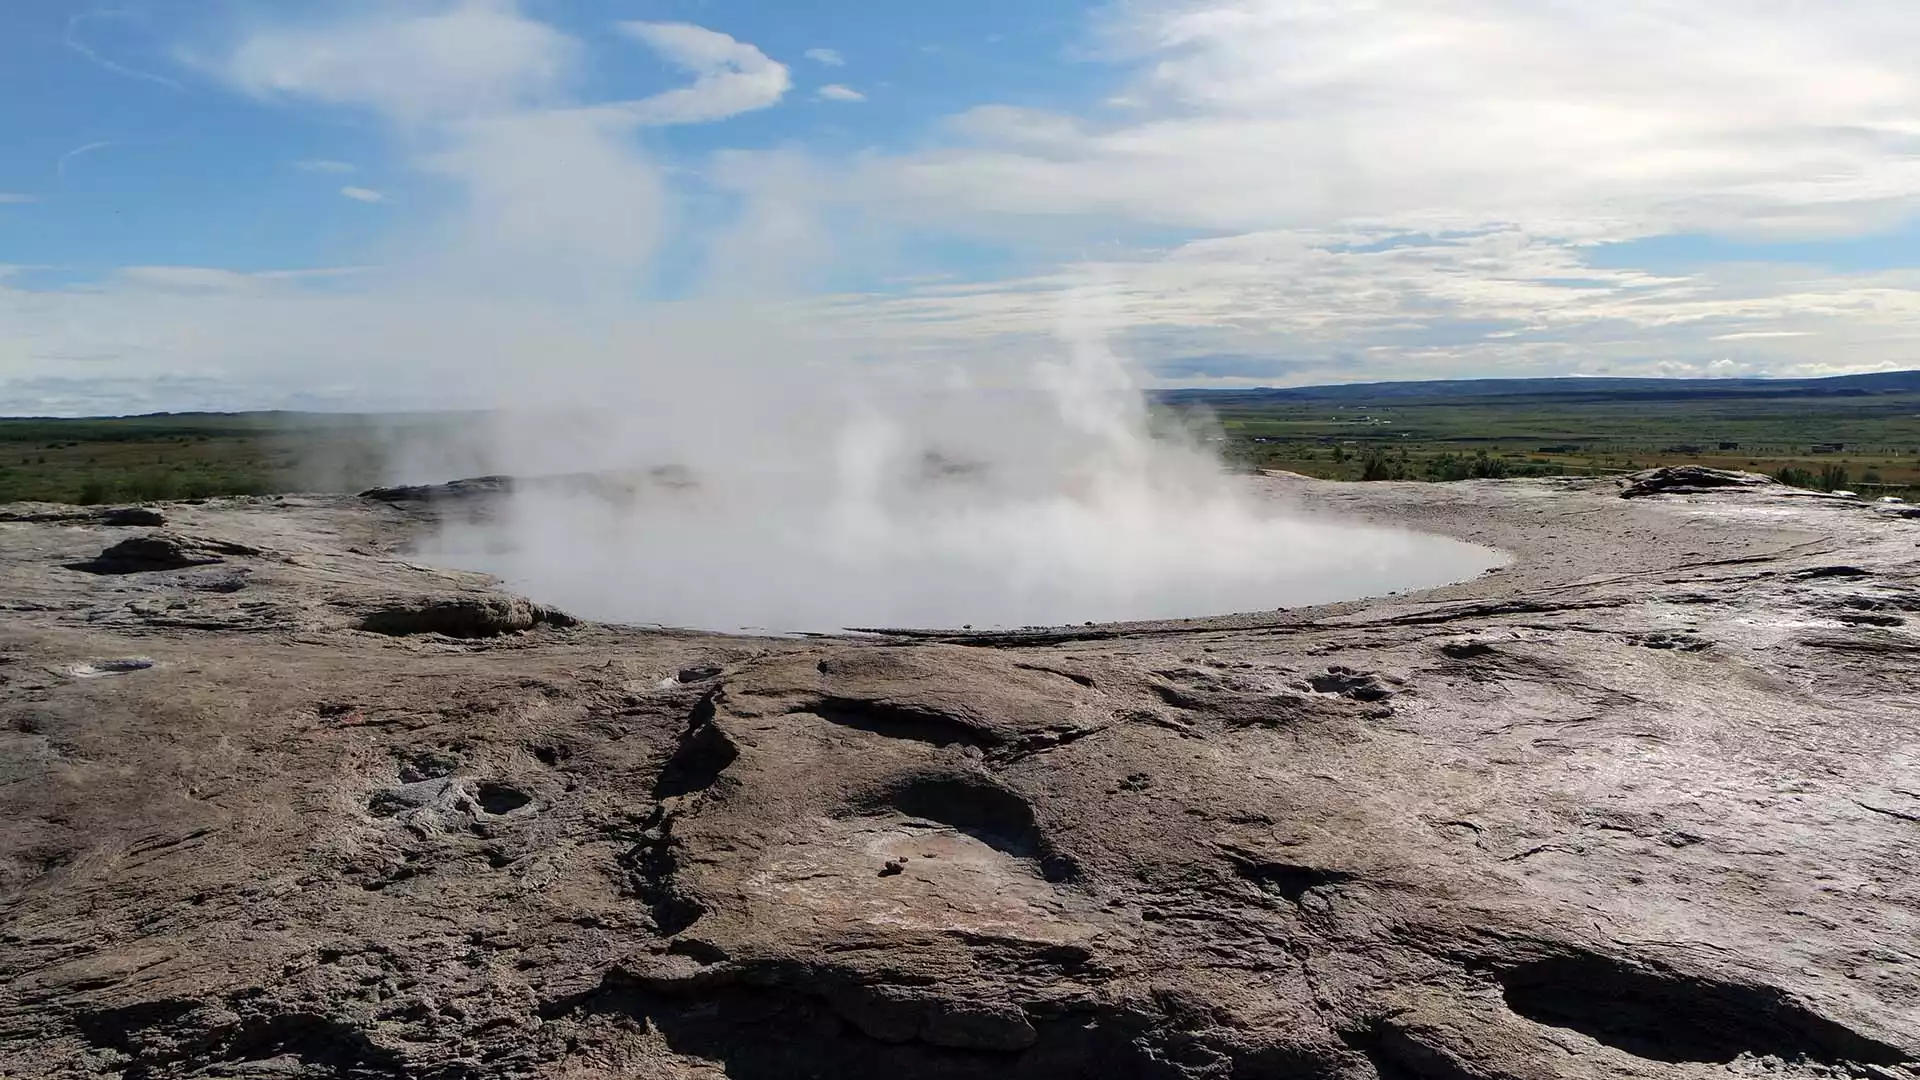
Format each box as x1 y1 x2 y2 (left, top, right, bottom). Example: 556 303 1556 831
202 0 1490 630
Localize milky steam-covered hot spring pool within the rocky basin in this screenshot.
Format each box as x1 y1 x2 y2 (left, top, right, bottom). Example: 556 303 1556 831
419 470 1507 632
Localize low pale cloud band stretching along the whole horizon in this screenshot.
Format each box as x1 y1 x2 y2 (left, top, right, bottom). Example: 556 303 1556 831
15 222 1920 411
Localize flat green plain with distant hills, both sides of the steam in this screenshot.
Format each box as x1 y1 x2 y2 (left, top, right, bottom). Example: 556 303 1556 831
0 373 1920 503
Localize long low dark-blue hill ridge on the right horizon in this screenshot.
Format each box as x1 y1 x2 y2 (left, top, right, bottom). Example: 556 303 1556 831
1154 371 1920 405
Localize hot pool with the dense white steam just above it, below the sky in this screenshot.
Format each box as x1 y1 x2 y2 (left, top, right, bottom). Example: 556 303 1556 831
422 332 1501 632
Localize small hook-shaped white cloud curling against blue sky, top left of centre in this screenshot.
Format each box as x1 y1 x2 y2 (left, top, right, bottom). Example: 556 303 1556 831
618 23 793 125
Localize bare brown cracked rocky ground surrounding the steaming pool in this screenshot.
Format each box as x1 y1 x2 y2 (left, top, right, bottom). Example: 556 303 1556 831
0 479 1920 1080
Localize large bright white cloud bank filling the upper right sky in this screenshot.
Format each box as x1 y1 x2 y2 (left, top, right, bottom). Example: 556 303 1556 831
887 0 1920 236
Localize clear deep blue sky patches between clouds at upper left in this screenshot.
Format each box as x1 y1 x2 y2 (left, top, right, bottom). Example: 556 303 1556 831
0 0 1089 277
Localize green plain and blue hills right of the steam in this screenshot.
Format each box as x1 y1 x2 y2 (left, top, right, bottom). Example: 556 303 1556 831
1162 365 1920 496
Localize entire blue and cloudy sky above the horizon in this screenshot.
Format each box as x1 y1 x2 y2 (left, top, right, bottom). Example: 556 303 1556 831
0 0 1920 415
